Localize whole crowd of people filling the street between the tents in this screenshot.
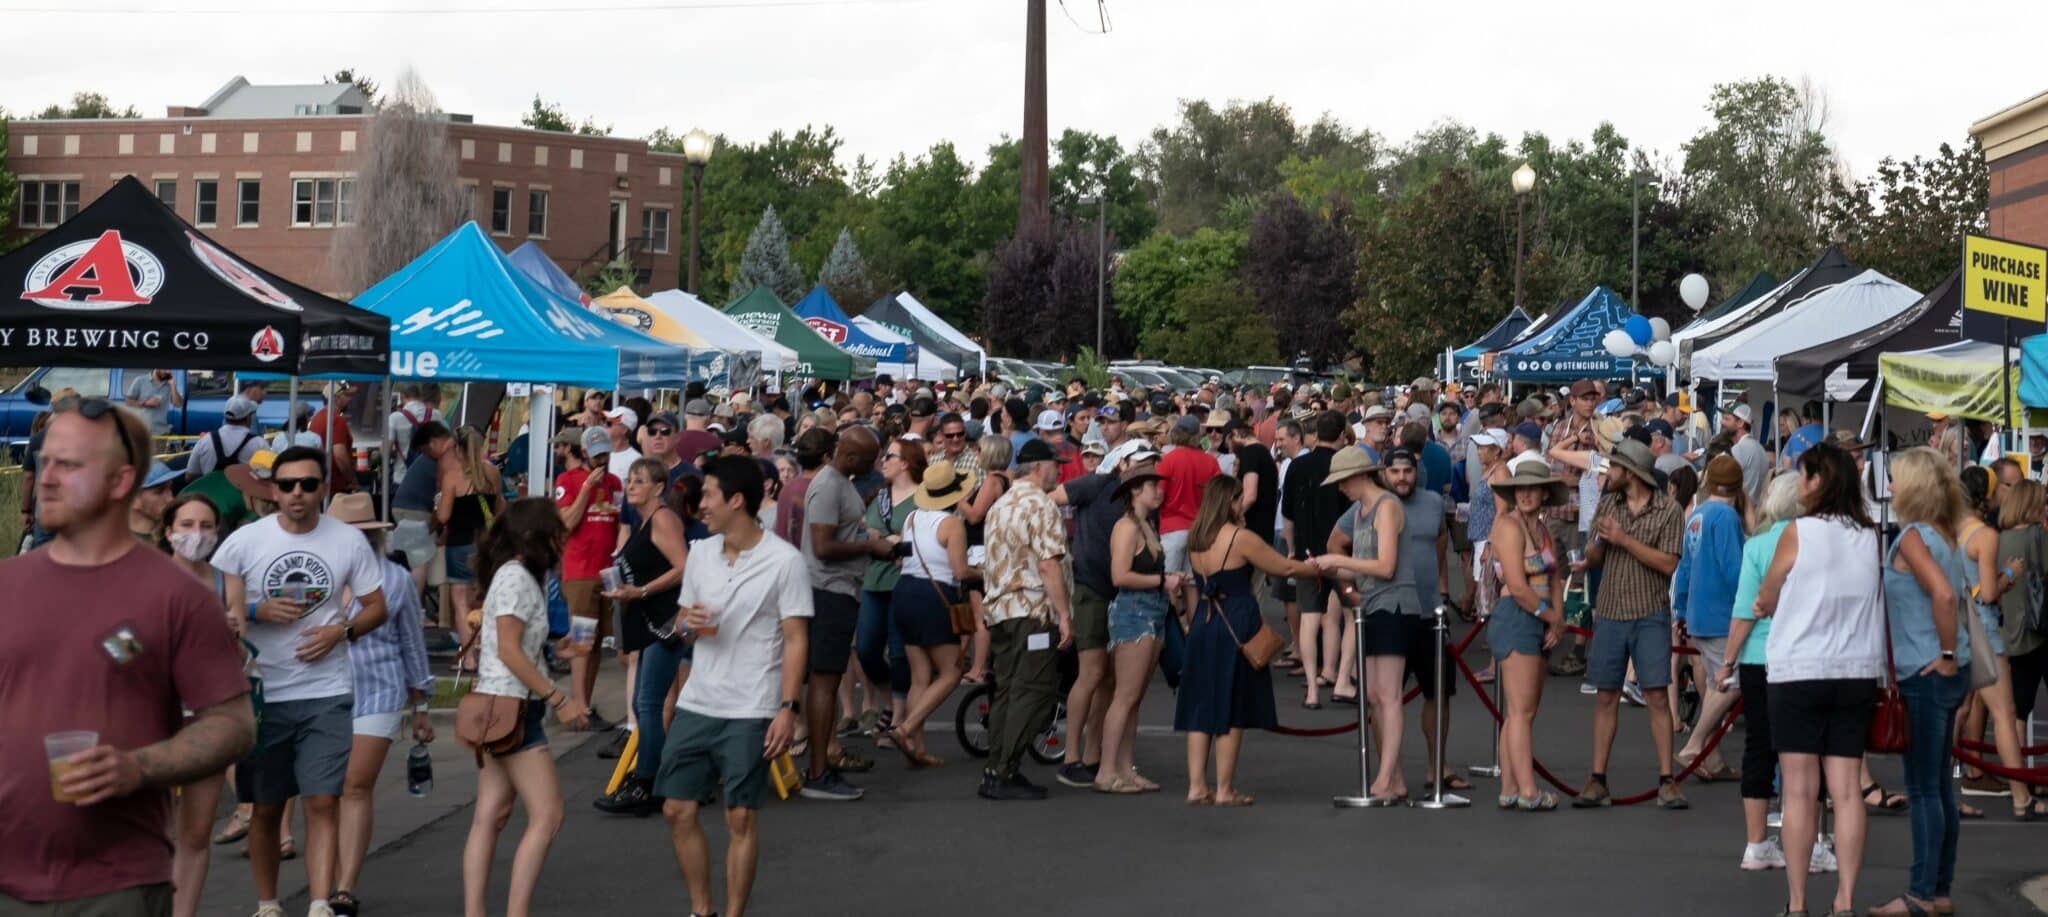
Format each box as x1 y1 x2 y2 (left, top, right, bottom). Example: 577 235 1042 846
0 366 2048 917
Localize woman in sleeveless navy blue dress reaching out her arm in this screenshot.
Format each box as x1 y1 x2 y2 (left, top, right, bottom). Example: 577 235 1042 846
1174 475 1319 806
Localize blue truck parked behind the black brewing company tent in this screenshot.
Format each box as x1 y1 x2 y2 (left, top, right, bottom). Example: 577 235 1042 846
0 366 322 461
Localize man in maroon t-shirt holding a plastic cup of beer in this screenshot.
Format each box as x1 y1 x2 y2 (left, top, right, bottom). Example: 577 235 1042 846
0 401 256 915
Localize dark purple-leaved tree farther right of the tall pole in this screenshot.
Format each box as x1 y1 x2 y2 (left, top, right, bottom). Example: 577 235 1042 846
1236 190 1358 364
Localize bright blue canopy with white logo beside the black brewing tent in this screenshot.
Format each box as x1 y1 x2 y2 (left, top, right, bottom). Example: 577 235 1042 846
354 221 704 389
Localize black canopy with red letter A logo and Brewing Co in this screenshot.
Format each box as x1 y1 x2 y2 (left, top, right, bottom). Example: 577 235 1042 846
0 176 391 377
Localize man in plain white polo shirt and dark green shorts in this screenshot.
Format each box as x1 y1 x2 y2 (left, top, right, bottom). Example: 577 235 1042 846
653 456 811 915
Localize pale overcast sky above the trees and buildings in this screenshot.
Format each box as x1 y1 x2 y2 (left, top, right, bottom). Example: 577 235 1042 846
0 0 2048 174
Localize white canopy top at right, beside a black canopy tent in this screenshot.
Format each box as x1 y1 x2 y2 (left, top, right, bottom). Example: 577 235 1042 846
1692 270 1921 383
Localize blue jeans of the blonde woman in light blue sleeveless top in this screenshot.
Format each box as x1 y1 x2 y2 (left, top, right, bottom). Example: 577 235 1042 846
1898 665 1970 901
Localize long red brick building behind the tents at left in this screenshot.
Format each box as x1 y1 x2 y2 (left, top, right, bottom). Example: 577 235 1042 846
6 76 688 299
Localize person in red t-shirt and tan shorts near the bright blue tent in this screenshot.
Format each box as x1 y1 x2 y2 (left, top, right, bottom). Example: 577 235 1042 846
555 426 625 731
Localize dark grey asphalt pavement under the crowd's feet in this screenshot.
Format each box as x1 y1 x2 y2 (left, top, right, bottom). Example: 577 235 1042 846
205 614 2048 917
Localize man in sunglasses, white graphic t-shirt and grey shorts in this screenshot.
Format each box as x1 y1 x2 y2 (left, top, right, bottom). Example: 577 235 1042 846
213 446 385 917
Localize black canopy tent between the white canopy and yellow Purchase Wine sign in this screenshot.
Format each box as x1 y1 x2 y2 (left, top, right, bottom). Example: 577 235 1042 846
1774 268 1964 401
